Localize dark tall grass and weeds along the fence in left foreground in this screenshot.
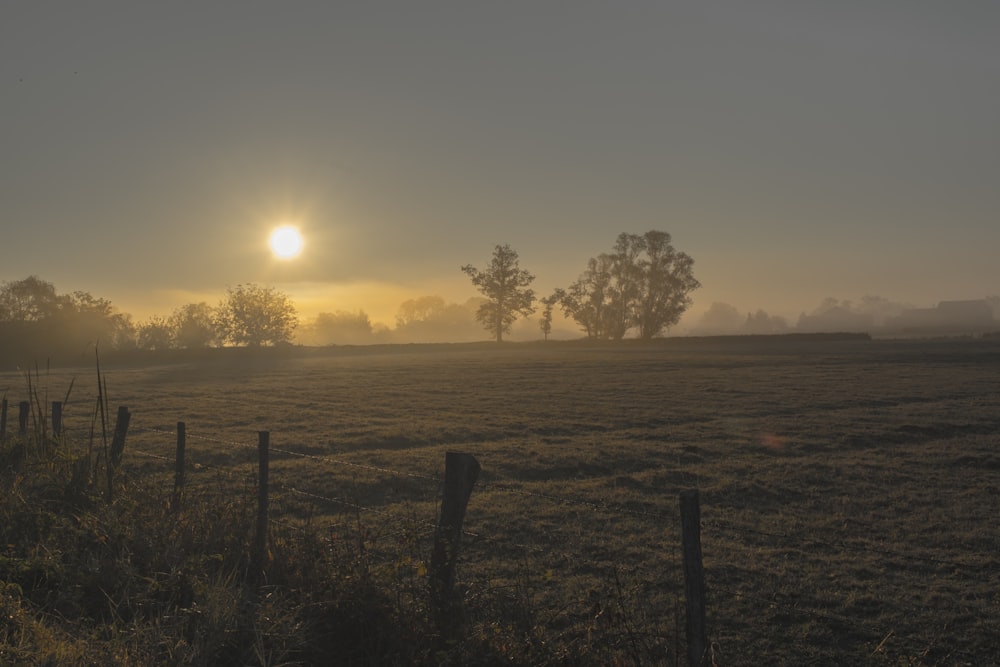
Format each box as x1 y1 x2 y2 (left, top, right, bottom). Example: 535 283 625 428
0 360 664 666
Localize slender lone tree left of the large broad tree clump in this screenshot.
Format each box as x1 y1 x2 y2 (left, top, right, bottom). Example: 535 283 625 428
462 244 535 343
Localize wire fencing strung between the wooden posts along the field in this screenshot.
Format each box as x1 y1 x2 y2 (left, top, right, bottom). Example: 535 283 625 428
1 399 1000 664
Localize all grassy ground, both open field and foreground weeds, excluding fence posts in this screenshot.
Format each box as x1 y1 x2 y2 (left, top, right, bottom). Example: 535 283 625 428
0 335 1000 667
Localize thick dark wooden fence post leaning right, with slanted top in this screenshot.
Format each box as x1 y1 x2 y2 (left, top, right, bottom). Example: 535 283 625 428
430 452 480 634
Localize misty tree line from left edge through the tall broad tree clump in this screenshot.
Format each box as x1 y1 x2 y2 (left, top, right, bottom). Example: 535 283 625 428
0 231 699 359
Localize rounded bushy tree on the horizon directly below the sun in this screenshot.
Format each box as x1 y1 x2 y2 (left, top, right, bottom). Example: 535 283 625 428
215 283 298 347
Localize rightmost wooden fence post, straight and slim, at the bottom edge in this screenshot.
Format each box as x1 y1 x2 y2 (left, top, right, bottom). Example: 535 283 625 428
680 489 708 667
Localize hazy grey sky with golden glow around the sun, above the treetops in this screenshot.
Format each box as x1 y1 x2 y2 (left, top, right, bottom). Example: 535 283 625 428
0 0 1000 332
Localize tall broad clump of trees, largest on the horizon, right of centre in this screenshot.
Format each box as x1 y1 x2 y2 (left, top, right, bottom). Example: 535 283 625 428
560 231 701 340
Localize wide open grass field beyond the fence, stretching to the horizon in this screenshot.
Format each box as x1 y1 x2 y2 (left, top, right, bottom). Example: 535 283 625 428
0 338 1000 665
